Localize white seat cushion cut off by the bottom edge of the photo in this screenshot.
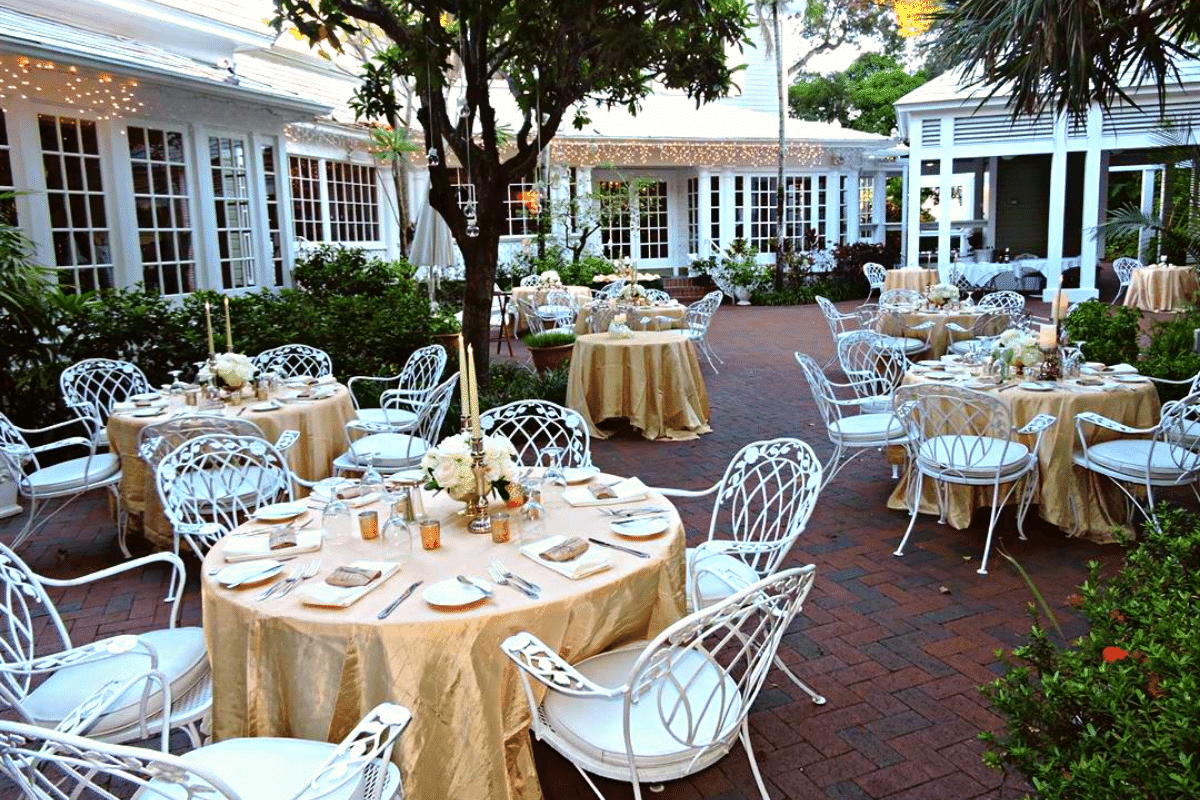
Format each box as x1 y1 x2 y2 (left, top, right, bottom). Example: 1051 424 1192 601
149 736 400 800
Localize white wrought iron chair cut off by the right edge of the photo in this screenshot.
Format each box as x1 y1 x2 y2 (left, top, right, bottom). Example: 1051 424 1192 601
1074 392 1200 522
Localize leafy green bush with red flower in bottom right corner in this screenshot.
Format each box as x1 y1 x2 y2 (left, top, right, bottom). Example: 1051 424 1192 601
982 510 1200 800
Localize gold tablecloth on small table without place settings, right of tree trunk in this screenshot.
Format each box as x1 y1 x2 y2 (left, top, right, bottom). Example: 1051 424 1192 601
566 331 712 439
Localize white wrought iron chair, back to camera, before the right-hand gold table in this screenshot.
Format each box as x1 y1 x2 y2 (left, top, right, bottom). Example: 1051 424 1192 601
894 384 1057 575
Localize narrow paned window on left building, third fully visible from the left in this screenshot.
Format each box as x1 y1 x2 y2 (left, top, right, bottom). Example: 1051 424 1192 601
209 137 258 289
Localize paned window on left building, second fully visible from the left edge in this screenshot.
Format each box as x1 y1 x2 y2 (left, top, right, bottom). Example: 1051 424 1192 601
125 125 196 295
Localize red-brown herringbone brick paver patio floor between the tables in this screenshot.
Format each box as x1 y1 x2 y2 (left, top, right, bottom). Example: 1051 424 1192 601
0 297 1122 800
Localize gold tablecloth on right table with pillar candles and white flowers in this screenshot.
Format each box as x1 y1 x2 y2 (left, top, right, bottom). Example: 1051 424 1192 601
888 373 1159 543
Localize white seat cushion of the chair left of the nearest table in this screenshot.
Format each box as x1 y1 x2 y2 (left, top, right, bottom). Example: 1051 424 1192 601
22 627 209 736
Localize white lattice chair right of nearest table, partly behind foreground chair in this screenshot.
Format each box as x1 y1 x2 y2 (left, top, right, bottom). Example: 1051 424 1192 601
655 438 826 705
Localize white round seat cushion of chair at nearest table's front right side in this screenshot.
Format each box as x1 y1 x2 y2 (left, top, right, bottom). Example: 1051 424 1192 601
542 644 742 775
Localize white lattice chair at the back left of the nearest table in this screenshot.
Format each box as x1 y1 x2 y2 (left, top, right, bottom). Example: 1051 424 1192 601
155 434 299 560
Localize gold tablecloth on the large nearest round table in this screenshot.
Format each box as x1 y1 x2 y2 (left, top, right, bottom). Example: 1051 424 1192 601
200 489 686 800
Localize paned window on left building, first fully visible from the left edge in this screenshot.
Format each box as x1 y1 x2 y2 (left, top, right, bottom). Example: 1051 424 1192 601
37 114 113 291
